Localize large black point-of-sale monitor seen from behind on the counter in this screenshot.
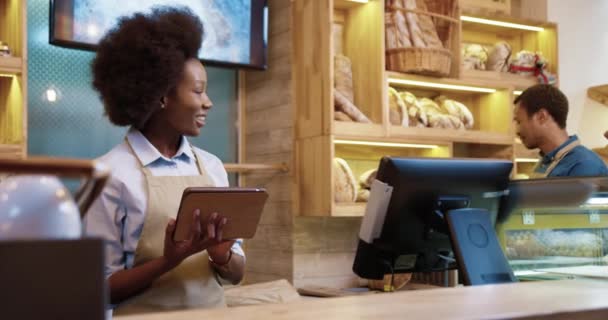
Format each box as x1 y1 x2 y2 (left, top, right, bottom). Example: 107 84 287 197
353 157 513 279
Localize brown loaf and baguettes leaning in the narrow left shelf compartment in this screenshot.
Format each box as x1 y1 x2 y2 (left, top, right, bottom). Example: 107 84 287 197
334 54 371 123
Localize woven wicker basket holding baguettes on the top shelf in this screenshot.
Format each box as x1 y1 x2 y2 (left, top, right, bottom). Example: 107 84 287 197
385 0 460 76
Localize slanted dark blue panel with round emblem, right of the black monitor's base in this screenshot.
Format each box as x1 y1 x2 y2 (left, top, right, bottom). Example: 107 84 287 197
446 208 517 286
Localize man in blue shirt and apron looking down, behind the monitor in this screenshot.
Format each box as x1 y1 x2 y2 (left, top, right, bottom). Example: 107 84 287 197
514 84 608 178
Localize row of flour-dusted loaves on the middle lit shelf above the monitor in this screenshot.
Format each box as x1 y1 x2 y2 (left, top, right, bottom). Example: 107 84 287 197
389 88 474 129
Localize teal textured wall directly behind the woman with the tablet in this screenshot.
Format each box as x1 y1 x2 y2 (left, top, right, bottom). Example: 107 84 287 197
27 0 237 162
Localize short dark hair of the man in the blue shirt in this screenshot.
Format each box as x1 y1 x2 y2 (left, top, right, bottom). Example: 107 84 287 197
513 84 568 129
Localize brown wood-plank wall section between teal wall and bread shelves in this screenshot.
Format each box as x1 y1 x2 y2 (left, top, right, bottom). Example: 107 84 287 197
241 0 294 283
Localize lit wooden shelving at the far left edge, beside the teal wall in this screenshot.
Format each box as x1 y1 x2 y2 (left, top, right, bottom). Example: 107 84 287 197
0 0 27 158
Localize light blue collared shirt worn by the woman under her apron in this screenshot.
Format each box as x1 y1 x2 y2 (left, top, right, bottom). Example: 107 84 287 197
84 129 245 277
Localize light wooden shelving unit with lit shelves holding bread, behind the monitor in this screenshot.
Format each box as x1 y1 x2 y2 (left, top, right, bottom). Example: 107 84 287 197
292 0 558 217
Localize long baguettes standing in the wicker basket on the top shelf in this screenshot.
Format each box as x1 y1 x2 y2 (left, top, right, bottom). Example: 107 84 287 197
384 0 443 49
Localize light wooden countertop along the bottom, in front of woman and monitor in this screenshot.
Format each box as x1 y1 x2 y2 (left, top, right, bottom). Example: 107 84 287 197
115 280 608 320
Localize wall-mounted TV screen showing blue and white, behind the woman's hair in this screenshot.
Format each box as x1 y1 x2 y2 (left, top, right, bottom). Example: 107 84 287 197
49 0 268 69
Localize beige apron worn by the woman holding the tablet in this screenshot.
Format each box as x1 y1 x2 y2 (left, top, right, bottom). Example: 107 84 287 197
114 141 226 314
